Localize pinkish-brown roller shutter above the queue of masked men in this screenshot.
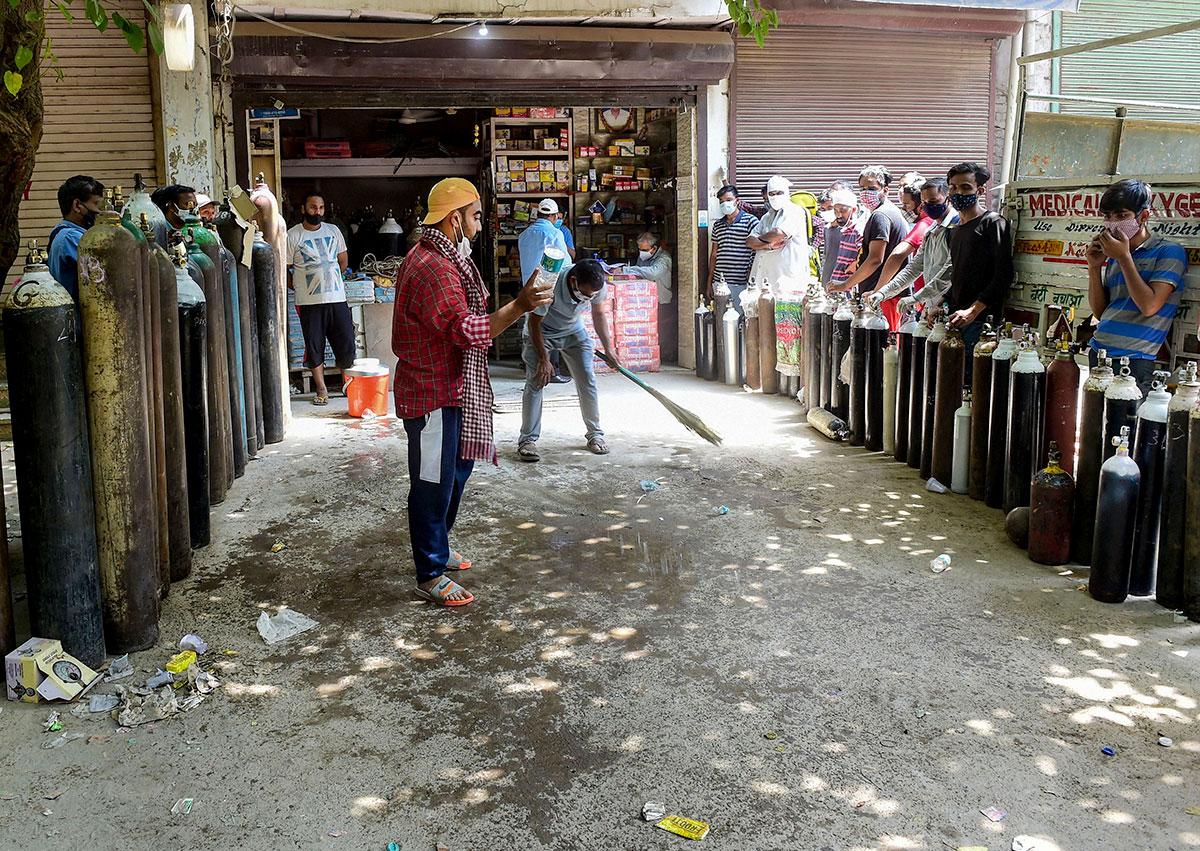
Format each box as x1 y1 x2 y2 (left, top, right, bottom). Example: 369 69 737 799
733 28 992 191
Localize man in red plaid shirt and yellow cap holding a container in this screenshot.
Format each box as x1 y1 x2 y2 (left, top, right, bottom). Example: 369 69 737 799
391 178 553 606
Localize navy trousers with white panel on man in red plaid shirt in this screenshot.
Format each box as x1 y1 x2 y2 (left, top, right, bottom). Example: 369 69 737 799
404 408 475 583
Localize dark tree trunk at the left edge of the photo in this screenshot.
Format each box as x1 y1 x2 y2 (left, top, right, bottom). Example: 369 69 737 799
0 0 45 275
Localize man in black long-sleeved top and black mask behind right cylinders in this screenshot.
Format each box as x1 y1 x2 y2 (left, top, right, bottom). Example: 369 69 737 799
946 162 1013 367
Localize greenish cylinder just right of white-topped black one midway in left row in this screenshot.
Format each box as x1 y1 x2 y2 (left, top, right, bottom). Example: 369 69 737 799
184 217 233 505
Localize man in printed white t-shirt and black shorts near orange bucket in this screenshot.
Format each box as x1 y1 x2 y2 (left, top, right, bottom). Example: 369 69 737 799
288 193 354 404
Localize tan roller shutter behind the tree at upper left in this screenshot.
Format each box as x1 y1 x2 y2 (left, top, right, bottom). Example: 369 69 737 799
10 0 158 278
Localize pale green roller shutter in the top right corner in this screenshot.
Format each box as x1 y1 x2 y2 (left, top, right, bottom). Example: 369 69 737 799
1058 0 1200 121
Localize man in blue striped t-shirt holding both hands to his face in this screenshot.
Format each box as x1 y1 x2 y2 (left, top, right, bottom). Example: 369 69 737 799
1087 180 1188 394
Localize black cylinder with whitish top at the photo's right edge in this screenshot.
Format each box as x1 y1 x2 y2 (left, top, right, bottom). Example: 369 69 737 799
1154 361 1200 609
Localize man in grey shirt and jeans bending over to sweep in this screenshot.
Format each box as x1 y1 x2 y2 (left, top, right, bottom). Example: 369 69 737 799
517 260 616 462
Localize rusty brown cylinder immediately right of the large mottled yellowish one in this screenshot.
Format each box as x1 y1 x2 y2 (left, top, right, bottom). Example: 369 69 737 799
112 198 170 597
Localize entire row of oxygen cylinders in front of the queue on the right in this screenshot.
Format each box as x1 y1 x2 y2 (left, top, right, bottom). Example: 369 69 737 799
696 290 1200 619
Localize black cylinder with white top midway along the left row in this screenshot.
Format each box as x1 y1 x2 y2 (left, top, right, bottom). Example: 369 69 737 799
175 242 211 547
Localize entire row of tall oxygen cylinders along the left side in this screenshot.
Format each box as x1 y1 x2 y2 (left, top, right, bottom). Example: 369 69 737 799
4 183 288 665
